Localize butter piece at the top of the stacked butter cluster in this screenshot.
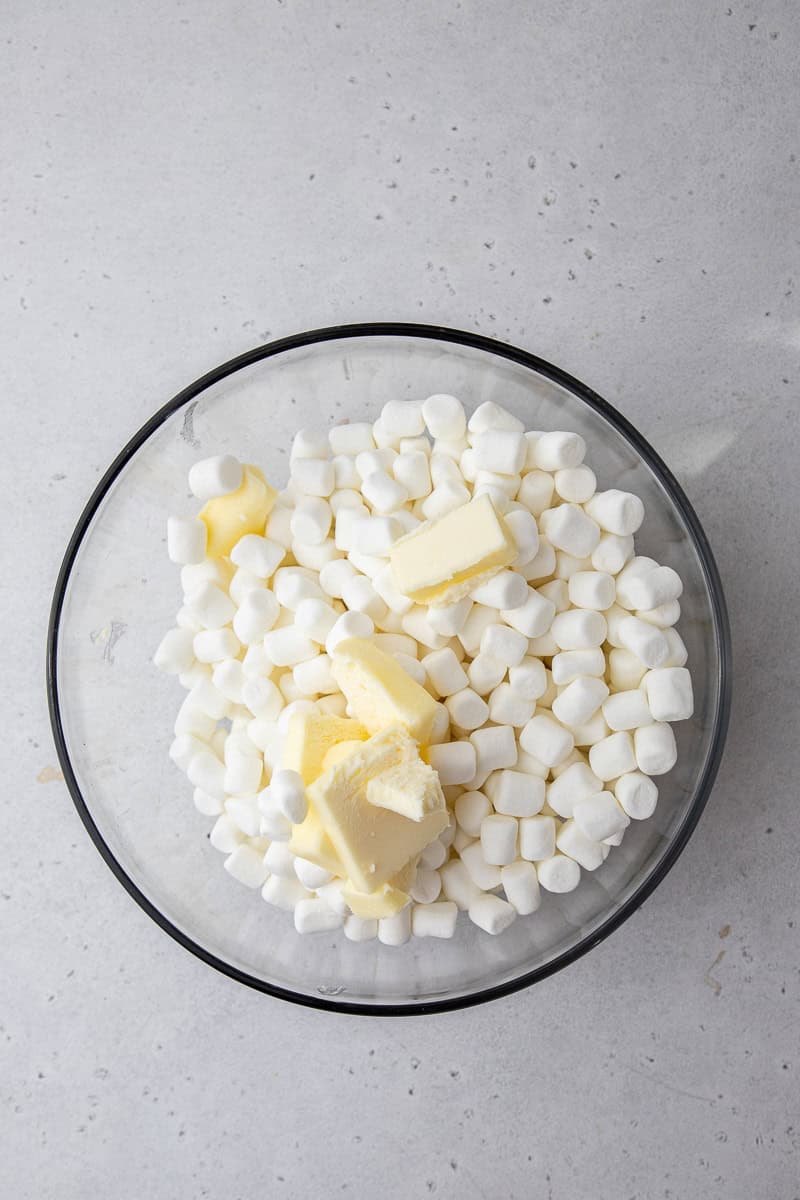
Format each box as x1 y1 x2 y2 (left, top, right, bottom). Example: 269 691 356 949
331 637 437 742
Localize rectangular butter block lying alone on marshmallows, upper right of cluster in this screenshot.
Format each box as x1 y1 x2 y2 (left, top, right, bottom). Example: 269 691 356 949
390 493 517 606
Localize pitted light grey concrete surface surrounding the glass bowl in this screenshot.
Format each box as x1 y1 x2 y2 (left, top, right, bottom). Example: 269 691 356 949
0 0 800 1200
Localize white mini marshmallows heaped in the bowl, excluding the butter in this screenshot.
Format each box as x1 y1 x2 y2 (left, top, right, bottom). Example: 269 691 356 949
155 395 693 946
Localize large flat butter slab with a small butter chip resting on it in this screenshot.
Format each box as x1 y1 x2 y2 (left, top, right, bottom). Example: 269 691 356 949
308 725 449 892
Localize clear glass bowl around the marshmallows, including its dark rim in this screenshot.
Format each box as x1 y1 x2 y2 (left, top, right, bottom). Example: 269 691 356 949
47 324 730 1015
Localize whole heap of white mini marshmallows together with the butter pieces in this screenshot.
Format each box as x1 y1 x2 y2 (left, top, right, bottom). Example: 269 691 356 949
155 395 693 946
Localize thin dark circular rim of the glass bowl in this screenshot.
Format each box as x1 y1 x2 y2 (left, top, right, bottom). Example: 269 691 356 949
46 322 732 1016
